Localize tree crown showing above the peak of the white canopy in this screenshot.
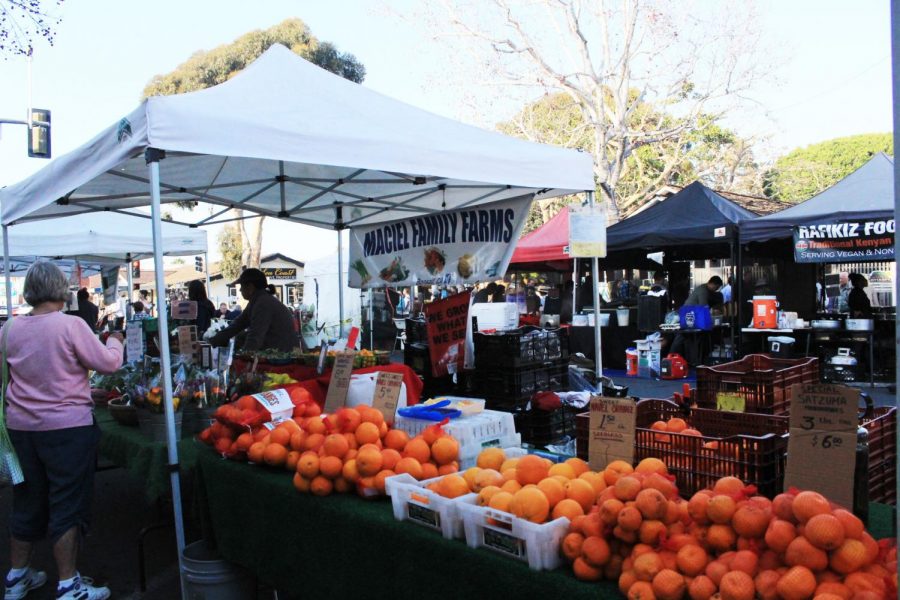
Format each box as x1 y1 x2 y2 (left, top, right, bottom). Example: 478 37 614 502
143 19 366 98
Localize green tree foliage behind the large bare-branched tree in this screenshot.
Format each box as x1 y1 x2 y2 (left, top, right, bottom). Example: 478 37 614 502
497 93 760 233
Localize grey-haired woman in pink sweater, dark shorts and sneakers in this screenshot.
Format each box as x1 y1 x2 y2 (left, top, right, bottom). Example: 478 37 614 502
0 261 122 600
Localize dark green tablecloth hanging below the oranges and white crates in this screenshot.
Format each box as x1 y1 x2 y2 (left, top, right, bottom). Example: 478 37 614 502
197 451 892 600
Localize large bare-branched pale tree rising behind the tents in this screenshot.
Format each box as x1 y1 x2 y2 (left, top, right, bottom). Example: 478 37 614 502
410 0 771 222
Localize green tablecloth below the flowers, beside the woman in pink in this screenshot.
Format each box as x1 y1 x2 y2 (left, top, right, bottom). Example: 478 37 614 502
94 407 205 501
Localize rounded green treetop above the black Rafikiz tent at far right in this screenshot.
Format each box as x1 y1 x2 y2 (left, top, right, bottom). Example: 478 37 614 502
764 133 894 202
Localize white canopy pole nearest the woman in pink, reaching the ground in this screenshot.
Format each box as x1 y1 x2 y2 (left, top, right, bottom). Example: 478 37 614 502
145 148 187 600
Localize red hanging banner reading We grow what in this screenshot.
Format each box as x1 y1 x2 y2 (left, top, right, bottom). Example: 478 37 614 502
425 292 472 377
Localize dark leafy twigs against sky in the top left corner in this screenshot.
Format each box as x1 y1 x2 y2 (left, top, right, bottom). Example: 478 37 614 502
0 0 63 58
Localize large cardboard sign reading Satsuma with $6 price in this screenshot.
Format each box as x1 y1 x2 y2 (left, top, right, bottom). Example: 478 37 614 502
784 383 859 509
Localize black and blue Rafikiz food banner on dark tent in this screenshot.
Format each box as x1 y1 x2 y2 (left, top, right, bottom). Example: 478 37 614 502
794 219 894 263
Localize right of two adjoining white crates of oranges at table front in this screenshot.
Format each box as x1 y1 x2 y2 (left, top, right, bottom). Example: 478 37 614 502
458 504 569 571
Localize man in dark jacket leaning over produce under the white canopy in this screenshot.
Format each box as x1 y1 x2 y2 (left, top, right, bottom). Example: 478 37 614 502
210 269 300 352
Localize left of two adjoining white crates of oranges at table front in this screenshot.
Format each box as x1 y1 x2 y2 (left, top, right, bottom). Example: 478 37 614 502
384 473 478 540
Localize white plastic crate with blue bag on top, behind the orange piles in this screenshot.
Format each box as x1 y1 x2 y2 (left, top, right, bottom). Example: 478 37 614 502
394 410 522 469
